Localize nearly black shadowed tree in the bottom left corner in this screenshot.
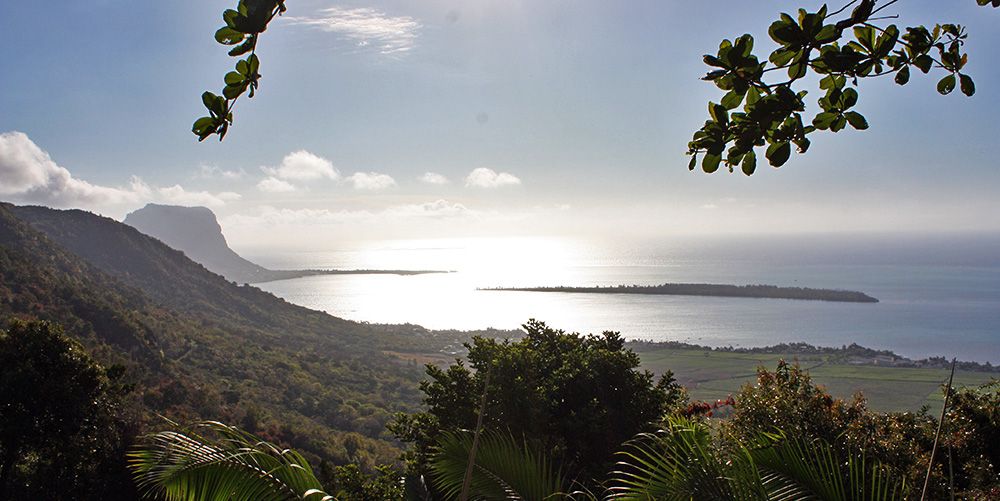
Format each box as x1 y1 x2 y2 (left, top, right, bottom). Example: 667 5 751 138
0 320 135 499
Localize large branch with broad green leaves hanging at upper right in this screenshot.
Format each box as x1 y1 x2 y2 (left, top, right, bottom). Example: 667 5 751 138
687 0 984 176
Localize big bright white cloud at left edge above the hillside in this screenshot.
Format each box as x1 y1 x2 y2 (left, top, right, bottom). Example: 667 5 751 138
0 132 240 210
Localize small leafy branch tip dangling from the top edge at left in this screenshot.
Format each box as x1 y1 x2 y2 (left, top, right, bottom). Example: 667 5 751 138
191 0 286 141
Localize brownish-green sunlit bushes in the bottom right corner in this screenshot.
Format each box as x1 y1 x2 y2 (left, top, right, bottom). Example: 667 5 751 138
720 362 1000 499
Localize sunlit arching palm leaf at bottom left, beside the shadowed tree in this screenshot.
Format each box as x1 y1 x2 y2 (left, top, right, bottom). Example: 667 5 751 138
128 421 333 501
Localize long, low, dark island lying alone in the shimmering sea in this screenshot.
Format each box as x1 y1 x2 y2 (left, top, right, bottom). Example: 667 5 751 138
476 283 878 303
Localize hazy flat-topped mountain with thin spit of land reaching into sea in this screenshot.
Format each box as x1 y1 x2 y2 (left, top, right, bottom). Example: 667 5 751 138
124 204 442 284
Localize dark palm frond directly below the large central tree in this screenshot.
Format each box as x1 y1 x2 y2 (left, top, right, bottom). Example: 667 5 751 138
429 432 565 500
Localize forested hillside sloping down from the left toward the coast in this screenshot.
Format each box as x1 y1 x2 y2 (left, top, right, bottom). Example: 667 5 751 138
0 203 446 463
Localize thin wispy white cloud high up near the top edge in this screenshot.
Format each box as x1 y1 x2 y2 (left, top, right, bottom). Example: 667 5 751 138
285 7 421 55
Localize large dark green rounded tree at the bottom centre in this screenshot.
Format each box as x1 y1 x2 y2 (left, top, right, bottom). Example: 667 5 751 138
390 320 682 482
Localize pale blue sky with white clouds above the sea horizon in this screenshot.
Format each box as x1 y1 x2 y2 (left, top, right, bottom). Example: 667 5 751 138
0 0 1000 249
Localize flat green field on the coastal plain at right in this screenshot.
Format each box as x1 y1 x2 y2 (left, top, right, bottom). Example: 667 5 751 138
638 348 1000 412
